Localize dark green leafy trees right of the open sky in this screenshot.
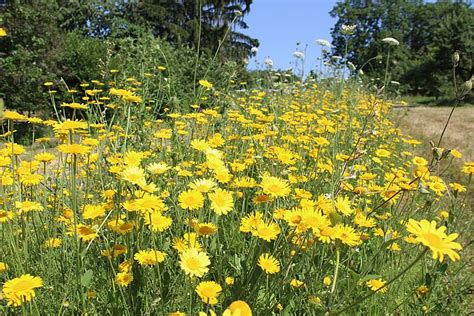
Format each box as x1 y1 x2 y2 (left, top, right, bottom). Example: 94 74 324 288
331 0 474 96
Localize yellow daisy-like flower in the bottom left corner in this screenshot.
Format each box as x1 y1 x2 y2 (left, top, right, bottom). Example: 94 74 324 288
2 274 43 306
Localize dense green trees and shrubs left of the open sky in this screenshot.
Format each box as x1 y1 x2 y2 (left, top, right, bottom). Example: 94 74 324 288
0 0 258 112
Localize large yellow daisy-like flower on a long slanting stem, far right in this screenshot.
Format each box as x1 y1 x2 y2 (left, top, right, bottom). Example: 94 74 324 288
407 219 462 262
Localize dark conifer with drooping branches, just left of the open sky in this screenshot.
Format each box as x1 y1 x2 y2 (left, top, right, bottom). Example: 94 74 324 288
126 0 258 61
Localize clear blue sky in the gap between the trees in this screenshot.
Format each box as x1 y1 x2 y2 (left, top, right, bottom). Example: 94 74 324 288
243 0 338 70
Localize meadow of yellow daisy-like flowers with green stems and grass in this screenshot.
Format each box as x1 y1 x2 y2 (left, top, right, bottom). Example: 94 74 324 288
0 1 474 316
